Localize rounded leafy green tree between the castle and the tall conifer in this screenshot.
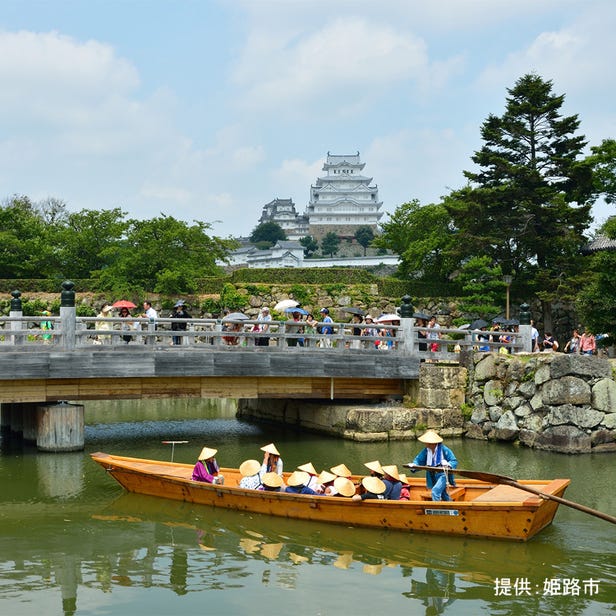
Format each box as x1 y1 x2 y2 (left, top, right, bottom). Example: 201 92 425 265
373 199 457 282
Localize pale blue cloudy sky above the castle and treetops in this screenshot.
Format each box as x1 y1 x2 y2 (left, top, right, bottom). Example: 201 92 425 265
0 0 616 237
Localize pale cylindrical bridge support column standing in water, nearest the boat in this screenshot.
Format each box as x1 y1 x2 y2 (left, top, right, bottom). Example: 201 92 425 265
36 402 84 452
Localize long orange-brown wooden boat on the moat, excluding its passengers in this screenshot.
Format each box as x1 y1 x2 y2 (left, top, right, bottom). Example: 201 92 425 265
91 452 569 541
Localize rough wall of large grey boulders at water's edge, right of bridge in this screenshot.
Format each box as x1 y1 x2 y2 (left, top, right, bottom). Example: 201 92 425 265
465 353 616 453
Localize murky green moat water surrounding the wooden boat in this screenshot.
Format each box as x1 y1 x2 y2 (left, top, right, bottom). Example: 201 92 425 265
0 401 616 616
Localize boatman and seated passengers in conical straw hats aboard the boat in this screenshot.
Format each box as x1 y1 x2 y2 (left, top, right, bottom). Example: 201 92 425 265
192 430 458 501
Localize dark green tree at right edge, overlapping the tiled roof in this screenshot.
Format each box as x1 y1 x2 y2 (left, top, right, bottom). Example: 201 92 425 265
576 217 616 344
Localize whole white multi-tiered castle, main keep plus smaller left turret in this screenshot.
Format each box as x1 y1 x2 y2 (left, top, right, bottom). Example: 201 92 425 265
259 152 383 240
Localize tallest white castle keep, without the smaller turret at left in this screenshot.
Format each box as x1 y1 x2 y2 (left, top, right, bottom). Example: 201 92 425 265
305 152 383 240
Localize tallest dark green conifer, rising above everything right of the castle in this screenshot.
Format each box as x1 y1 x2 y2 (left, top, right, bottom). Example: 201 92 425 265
444 74 593 329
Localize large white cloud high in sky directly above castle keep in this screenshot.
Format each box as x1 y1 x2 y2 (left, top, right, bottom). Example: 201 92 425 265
234 17 434 112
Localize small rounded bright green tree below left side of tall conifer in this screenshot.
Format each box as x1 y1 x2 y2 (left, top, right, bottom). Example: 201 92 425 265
456 256 505 320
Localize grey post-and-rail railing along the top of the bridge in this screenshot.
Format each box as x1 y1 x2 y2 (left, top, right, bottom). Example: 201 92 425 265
0 309 531 362
